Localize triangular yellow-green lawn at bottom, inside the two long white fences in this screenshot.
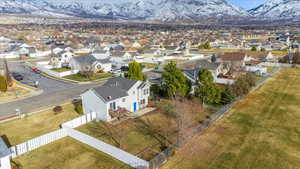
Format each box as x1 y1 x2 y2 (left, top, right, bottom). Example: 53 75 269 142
13 137 131 169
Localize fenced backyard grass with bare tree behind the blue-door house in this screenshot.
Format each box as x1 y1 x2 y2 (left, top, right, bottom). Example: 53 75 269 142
78 100 211 160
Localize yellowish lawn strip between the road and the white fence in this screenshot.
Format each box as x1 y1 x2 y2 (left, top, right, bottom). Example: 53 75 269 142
0 104 79 145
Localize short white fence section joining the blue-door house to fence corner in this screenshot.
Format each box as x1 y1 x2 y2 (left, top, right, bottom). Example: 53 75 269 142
61 112 96 128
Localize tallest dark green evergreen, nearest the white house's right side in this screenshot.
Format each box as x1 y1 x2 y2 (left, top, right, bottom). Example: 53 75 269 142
162 62 189 97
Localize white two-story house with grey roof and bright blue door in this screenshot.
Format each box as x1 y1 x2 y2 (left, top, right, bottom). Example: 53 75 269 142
81 77 150 121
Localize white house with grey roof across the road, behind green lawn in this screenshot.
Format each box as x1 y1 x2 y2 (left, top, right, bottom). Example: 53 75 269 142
69 56 112 73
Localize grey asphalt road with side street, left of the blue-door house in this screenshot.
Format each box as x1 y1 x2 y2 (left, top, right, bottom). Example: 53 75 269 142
0 62 104 118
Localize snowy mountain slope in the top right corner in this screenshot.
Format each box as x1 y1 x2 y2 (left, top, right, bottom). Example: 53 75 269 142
249 0 300 19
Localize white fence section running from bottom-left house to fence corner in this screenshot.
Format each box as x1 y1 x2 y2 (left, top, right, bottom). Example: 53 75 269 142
10 129 68 158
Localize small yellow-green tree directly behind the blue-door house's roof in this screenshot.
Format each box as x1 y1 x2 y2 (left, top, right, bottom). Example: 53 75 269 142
126 61 146 81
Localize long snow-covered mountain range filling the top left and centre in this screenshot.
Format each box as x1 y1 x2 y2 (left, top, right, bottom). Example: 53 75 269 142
0 0 249 21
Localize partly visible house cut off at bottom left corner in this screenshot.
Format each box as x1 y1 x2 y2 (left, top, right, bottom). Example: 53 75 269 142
0 137 11 169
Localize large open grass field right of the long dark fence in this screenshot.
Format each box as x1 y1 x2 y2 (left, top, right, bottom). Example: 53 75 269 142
162 69 300 169
